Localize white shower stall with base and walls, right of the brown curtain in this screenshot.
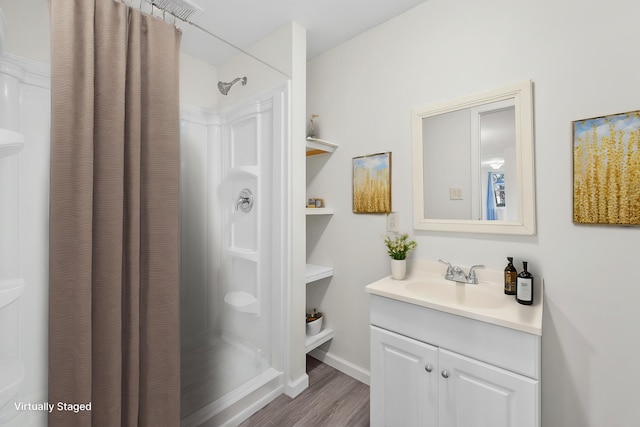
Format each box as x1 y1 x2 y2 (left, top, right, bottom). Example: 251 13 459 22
181 84 288 426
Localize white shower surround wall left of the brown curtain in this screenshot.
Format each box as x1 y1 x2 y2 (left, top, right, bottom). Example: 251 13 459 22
0 54 50 427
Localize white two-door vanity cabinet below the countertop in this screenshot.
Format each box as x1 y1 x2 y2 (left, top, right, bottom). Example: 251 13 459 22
371 294 540 427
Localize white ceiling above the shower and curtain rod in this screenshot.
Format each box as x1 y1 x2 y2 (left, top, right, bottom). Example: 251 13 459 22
172 0 426 65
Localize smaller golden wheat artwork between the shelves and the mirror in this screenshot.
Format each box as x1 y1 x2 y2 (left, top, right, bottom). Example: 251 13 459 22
353 152 391 213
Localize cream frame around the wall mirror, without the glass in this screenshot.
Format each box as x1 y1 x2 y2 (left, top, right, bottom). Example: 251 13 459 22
411 81 536 235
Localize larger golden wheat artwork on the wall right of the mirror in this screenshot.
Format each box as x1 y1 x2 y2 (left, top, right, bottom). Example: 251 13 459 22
573 111 640 225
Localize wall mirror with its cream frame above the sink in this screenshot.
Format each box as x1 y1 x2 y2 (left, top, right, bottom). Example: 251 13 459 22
411 81 535 235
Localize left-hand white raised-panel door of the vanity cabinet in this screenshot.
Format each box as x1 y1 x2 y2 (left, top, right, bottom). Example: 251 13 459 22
370 326 438 427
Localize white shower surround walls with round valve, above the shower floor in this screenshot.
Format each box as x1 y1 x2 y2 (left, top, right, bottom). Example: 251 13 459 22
181 86 286 356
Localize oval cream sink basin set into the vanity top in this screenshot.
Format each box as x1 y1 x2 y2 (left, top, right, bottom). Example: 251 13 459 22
406 277 508 309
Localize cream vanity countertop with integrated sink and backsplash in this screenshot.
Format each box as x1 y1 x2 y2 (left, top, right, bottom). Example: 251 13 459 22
366 261 544 335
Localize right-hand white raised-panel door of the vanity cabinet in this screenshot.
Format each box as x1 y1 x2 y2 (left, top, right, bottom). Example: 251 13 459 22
438 349 540 427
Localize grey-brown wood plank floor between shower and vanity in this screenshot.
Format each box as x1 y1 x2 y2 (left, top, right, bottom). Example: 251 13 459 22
240 356 369 427
